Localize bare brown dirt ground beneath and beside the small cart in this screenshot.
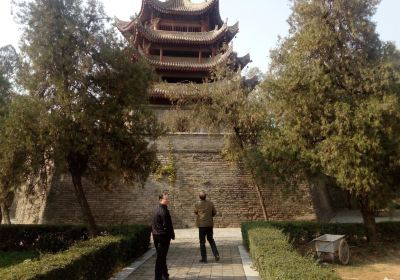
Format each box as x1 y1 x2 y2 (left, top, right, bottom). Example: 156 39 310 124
301 242 400 280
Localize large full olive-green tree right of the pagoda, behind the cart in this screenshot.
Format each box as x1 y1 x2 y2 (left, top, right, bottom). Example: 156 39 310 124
263 0 400 241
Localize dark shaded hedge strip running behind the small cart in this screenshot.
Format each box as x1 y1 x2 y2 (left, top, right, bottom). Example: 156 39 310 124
242 221 400 244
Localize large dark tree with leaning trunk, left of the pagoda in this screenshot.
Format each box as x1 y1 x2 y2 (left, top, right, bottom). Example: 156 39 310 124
18 0 161 236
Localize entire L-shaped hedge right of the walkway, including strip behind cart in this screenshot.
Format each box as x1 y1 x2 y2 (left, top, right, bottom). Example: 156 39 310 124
242 222 400 280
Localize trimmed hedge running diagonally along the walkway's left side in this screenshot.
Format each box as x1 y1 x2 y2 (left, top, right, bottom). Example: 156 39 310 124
0 226 150 280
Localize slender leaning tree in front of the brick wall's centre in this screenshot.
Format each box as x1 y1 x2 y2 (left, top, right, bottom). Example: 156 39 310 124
171 66 270 220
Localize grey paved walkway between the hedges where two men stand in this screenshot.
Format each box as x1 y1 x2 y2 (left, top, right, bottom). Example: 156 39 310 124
127 229 259 280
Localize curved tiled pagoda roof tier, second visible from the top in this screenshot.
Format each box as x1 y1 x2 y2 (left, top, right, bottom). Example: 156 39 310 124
115 19 239 45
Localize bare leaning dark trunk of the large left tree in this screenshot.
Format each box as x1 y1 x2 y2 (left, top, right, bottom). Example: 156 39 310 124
71 173 99 238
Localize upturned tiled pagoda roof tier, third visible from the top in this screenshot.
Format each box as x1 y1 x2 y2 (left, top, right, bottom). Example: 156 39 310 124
138 45 233 72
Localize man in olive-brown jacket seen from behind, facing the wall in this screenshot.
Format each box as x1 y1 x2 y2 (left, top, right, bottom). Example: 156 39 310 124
194 191 219 263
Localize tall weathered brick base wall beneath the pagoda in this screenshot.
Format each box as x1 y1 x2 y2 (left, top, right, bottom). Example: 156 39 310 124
15 134 315 228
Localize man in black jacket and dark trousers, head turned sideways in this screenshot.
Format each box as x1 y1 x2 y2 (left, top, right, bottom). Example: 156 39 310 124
152 192 175 280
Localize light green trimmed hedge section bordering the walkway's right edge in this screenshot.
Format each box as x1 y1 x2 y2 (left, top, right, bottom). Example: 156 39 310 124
246 226 340 280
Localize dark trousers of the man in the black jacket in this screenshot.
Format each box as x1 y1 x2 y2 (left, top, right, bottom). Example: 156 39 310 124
153 235 171 280
